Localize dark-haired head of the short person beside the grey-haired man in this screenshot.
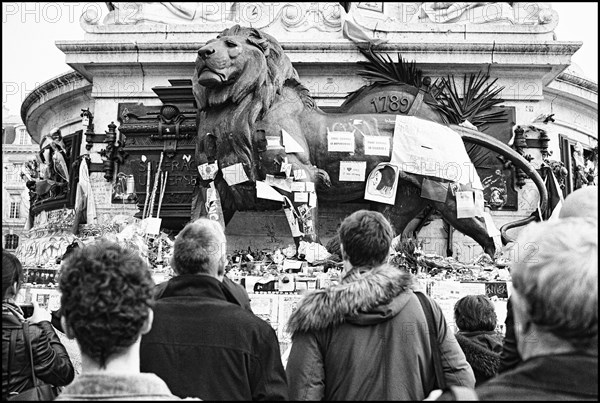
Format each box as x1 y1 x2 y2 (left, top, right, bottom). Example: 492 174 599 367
454 295 498 332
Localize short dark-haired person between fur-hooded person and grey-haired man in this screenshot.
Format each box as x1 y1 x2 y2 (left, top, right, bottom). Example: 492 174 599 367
454 295 504 386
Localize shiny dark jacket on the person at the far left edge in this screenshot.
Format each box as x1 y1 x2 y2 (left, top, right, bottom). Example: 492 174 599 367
2 301 75 400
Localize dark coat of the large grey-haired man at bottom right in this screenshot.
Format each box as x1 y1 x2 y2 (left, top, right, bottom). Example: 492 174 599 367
475 354 598 401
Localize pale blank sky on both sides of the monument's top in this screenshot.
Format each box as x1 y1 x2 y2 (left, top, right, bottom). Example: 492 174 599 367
2 2 598 120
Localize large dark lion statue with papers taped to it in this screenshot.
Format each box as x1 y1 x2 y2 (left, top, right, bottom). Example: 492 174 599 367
192 25 546 256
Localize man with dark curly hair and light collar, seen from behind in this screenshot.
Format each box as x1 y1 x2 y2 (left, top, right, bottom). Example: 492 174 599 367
57 240 190 400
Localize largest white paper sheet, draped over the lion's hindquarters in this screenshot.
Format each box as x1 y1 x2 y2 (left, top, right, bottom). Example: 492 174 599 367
390 115 483 189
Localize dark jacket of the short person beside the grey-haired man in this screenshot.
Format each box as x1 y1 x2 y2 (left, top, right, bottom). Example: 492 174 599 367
456 331 502 386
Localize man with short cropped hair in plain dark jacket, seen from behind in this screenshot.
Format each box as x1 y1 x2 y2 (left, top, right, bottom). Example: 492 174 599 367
140 219 288 400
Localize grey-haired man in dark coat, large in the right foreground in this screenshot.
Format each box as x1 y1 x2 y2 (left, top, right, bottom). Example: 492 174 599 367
454 217 598 401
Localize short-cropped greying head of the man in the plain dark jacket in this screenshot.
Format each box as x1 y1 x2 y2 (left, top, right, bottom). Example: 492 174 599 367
171 218 227 280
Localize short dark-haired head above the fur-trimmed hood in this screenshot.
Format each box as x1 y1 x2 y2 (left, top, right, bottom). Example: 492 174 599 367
338 210 394 267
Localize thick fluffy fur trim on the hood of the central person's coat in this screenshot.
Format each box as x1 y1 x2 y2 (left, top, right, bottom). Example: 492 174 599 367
288 264 413 334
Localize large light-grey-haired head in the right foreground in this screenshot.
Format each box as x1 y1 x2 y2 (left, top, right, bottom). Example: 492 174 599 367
511 217 598 355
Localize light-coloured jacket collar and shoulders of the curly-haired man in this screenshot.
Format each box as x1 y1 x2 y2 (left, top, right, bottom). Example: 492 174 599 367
56 372 193 400
